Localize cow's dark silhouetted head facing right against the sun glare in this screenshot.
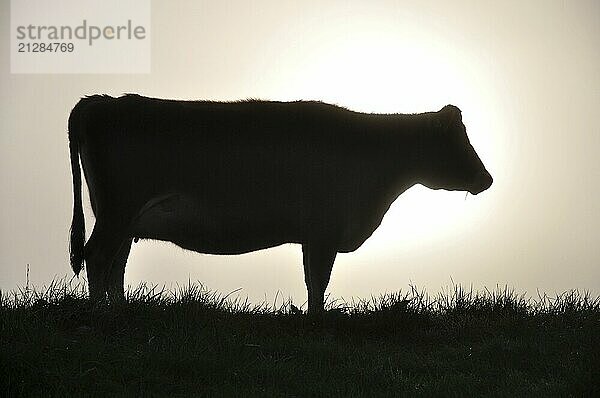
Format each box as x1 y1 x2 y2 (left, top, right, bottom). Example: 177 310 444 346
420 105 493 195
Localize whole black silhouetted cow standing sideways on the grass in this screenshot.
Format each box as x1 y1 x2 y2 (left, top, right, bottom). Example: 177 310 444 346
68 94 492 314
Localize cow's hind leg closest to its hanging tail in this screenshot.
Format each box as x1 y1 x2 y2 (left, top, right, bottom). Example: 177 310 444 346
84 220 125 301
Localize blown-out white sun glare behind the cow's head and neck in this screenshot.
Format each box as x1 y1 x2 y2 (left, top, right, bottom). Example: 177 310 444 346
256 20 493 247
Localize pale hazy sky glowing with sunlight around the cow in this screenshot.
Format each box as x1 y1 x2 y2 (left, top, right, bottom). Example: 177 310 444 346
0 0 600 303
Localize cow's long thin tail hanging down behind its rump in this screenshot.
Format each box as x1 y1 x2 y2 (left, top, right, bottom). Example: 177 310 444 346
69 102 85 275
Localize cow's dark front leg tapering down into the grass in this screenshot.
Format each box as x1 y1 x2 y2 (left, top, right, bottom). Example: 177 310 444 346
302 244 337 314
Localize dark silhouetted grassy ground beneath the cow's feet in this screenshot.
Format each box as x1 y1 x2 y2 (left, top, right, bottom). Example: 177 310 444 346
0 282 600 397
